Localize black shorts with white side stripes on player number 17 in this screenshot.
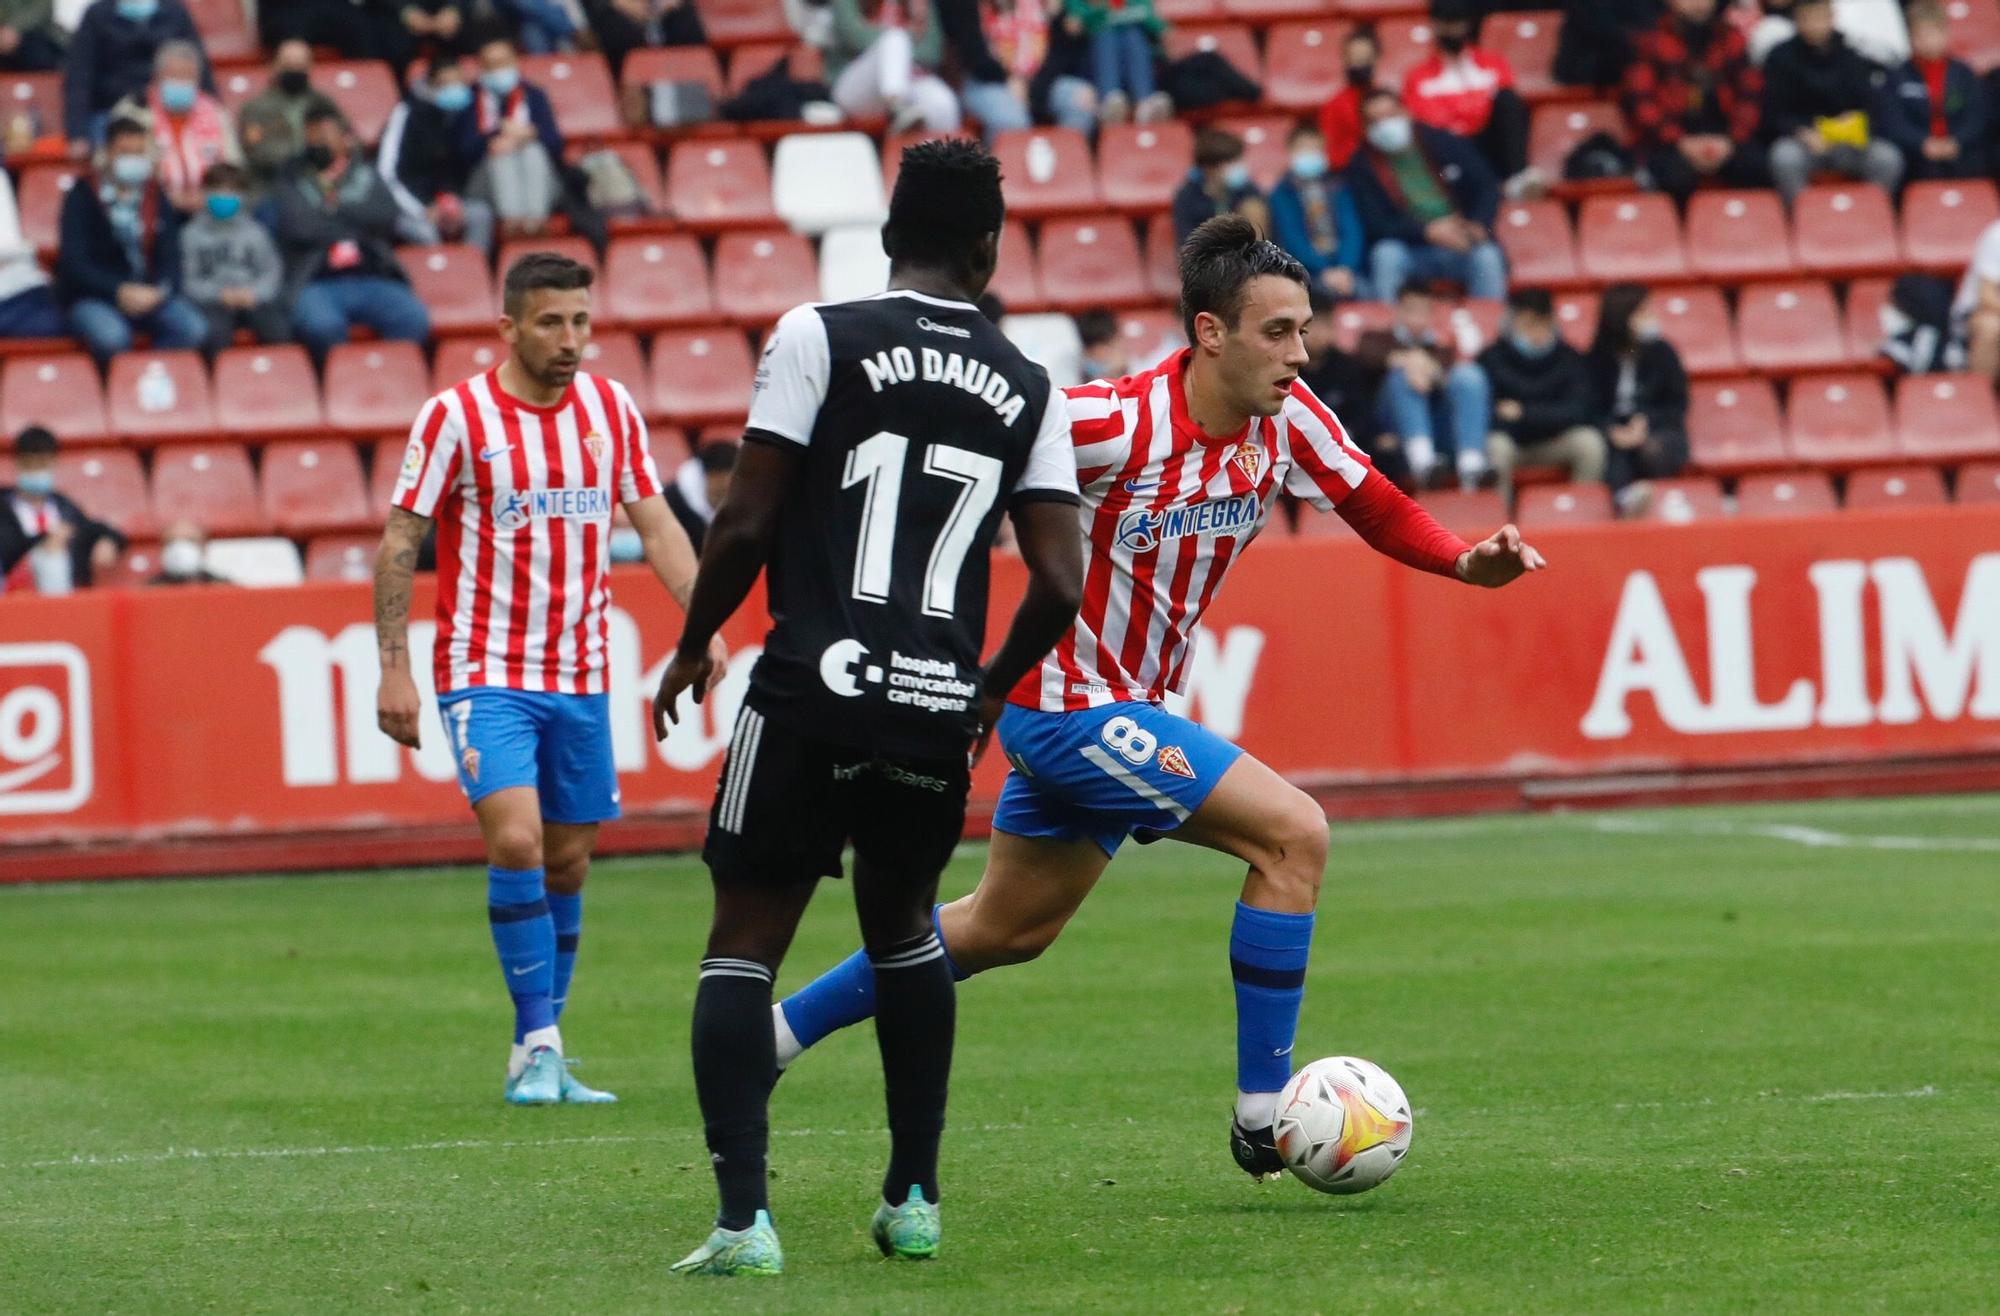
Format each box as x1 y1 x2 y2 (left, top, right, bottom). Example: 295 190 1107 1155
702 704 972 884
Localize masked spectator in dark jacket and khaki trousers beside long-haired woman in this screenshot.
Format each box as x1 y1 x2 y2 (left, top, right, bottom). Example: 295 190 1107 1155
1480 288 1606 504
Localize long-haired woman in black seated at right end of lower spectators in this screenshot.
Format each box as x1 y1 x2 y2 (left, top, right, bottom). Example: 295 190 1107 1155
1584 284 1688 516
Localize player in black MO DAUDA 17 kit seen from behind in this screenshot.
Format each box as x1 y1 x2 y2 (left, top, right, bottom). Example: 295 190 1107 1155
654 142 1084 1274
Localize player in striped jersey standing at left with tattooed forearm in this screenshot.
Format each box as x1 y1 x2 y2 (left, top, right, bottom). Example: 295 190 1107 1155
374 252 722 1106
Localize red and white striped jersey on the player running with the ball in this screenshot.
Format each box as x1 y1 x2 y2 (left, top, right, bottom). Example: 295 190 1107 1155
1012 350 1370 712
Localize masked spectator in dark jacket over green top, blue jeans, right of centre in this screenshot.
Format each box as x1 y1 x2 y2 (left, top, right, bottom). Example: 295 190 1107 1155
1346 90 1506 302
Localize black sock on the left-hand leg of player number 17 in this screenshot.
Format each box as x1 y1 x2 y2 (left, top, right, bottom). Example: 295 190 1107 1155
694 958 778 1230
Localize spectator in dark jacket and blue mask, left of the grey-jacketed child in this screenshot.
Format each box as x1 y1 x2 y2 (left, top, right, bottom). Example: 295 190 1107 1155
56 118 208 366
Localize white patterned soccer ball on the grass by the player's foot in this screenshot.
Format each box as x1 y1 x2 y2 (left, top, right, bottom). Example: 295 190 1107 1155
1274 1056 1412 1194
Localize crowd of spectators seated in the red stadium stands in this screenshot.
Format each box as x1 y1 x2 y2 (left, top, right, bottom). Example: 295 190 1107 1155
0 0 2000 592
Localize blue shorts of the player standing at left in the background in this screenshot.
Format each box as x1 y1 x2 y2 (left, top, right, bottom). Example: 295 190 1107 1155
438 688 618 822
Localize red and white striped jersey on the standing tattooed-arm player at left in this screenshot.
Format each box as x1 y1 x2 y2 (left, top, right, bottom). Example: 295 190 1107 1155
394 368 660 694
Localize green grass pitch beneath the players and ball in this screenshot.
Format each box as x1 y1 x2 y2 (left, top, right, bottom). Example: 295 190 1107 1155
0 798 2000 1316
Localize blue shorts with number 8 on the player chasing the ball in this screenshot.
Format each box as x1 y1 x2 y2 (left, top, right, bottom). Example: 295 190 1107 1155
994 702 1242 854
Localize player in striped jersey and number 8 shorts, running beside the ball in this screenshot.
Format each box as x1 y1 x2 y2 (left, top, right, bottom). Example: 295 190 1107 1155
772 216 1544 1176
